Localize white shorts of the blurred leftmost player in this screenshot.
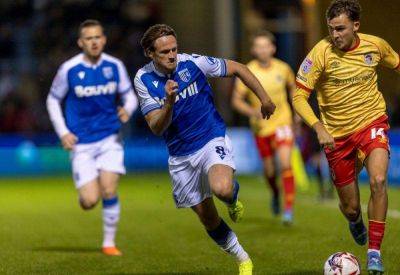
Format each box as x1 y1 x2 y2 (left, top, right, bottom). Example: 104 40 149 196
70 134 125 189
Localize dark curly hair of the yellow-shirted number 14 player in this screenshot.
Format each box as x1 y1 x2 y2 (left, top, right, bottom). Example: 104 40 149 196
326 0 361 22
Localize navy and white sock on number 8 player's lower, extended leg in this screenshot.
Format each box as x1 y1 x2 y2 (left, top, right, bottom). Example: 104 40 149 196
207 219 249 262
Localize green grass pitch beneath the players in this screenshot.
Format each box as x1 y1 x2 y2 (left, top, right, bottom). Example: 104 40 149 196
0 173 400 274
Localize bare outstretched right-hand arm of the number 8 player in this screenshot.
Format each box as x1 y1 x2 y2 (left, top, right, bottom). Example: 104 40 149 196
225 60 276 118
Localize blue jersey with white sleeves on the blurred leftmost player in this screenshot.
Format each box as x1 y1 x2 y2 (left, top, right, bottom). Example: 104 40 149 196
50 53 132 143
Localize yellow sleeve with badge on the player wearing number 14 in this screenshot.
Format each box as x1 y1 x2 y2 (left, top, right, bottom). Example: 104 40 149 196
296 44 325 92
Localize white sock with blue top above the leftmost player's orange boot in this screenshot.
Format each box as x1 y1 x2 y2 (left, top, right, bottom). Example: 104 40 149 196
103 196 120 247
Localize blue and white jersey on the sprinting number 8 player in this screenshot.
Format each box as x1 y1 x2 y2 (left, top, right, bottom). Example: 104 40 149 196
134 54 226 156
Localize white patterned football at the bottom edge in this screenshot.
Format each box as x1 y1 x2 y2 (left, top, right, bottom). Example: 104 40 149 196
324 252 361 275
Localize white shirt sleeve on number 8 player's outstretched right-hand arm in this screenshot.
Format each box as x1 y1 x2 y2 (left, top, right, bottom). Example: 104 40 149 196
192 54 226 77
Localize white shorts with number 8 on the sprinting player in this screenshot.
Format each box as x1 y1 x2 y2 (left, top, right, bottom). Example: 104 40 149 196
168 136 235 208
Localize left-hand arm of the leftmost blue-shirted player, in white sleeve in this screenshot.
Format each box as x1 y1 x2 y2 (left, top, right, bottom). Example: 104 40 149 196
46 67 78 150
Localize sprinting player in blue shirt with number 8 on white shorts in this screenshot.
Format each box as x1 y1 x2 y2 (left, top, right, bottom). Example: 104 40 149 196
134 24 275 274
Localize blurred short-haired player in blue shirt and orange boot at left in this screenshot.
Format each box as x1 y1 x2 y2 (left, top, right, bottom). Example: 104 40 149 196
47 20 137 256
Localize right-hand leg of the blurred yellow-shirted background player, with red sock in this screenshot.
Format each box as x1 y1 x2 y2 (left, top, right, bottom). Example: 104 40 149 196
276 144 295 224
